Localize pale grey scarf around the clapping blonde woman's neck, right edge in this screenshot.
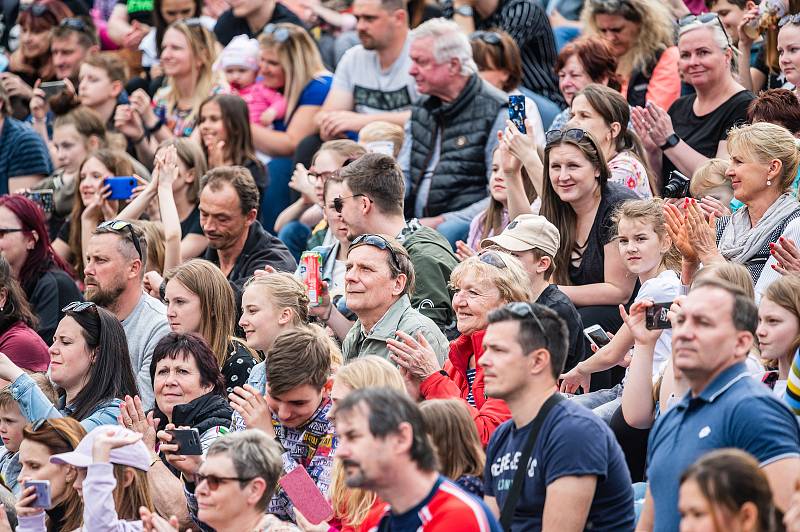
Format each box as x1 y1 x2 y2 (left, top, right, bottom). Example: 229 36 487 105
717 194 800 264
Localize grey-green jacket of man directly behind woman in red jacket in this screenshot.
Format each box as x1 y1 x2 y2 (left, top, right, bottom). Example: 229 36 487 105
342 295 450 365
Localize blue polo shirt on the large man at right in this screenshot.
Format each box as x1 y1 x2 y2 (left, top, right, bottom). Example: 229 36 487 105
647 363 800 532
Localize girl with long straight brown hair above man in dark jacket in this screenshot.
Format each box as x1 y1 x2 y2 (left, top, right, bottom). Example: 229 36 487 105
197 94 267 193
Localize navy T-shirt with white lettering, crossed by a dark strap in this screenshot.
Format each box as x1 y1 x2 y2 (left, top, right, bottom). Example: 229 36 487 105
484 401 635 532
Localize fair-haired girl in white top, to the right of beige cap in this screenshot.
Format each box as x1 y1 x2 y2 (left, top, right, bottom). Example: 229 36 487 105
560 200 681 422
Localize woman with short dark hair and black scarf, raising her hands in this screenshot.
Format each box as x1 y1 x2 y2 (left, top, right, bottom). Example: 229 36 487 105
119 332 233 523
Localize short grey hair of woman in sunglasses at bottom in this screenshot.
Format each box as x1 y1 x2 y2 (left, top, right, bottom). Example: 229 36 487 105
207 429 283 511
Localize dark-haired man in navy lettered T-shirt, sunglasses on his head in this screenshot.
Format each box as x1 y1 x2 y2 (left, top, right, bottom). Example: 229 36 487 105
478 303 634 532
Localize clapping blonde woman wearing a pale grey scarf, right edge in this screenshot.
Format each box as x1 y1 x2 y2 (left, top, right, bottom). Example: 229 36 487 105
667 122 800 289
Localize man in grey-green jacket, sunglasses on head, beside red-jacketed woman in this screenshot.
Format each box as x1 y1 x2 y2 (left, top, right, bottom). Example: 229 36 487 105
340 234 447 364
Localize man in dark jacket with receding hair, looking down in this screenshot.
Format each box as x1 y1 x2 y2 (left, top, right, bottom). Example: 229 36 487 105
200 166 297 308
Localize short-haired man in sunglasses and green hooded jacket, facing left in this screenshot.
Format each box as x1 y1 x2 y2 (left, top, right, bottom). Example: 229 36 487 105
334 153 458 334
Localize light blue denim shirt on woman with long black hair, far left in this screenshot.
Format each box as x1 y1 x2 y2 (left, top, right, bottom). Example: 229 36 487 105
11 373 122 432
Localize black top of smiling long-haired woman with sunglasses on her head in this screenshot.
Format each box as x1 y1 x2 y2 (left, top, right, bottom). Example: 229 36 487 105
569 183 639 286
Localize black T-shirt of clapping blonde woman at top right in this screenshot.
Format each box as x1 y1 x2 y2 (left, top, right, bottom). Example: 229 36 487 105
661 90 755 183
